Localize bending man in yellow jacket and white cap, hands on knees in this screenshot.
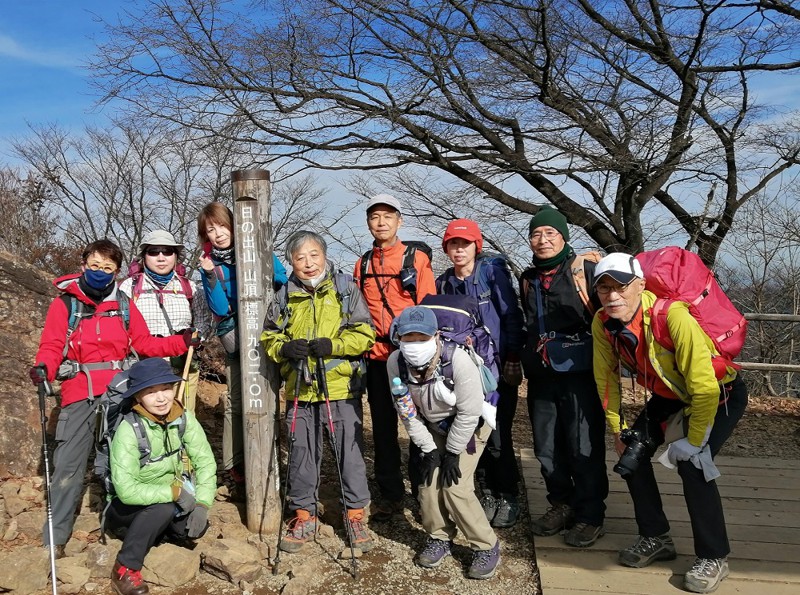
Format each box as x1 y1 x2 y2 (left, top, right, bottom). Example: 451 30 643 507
592 252 747 593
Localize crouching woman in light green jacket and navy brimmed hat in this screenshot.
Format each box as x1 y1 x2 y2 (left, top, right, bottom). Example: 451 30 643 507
107 358 217 595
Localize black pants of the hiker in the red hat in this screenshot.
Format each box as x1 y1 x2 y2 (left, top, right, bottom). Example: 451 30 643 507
475 378 519 495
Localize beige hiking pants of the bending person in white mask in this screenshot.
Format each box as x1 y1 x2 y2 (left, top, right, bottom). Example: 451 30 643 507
419 424 497 550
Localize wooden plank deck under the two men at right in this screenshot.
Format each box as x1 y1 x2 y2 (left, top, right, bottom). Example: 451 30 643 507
521 449 800 595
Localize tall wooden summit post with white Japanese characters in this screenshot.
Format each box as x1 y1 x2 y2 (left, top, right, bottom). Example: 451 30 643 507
231 169 281 539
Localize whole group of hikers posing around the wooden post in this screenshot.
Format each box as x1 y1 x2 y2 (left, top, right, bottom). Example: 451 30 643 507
30 194 747 595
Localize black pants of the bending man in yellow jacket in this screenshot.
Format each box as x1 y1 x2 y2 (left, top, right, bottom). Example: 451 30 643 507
627 376 747 559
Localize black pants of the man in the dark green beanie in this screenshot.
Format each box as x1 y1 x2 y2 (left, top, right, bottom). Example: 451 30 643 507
528 372 608 527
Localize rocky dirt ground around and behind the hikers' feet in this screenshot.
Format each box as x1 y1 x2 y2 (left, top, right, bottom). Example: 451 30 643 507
0 383 800 595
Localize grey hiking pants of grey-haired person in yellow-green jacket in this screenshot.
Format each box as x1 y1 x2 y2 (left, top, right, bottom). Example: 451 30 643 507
286 399 370 514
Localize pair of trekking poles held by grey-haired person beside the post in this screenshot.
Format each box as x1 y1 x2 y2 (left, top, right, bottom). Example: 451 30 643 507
272 357 358 579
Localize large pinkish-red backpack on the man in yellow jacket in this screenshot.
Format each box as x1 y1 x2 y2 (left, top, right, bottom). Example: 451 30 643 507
636 246 747 367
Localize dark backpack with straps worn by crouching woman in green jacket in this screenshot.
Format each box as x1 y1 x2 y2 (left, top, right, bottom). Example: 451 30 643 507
94 370 186 543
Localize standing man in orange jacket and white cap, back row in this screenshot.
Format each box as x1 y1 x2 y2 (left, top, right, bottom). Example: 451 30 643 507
353 194 436 522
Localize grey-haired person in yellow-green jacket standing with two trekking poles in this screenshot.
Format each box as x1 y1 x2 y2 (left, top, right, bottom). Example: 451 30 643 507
261 231 375 552
